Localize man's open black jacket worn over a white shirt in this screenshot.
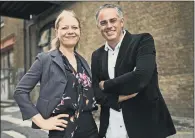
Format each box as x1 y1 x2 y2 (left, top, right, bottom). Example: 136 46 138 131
91 31 176 138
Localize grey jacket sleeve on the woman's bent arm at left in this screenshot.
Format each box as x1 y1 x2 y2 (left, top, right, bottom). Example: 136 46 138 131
14 54 42 120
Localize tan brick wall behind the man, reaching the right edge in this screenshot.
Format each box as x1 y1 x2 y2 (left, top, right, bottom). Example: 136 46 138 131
65 2 194 117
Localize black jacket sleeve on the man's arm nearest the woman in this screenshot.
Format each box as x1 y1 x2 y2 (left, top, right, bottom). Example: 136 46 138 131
91 52 119 110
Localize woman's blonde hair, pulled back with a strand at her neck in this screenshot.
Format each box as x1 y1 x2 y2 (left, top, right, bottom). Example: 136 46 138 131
50 10 81 51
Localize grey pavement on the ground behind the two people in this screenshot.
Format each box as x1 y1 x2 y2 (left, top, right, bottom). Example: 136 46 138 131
0 100 194 138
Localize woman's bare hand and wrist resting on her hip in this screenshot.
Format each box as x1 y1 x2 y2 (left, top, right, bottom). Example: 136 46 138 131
32 114 69 131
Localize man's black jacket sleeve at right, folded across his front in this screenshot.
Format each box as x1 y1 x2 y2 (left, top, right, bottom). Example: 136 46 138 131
104 33 156 95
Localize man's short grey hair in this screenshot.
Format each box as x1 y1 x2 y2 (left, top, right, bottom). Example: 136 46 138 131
95 4 123 24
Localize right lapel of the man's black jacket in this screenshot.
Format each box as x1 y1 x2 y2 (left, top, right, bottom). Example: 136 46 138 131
115 30 131 71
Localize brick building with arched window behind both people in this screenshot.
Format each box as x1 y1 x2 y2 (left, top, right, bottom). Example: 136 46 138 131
0 1 194 117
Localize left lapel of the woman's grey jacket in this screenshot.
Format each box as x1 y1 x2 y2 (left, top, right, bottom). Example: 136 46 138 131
51 49 66 75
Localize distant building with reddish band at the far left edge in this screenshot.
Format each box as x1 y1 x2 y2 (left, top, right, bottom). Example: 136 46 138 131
0 16 24 100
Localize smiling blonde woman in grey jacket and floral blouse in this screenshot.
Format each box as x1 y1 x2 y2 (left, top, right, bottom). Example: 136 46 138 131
14 10 98 138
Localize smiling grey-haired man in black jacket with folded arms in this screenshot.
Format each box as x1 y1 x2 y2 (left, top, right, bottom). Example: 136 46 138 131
91 4 176 138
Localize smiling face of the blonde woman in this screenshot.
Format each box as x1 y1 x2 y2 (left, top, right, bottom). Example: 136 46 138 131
56 15 80 48
